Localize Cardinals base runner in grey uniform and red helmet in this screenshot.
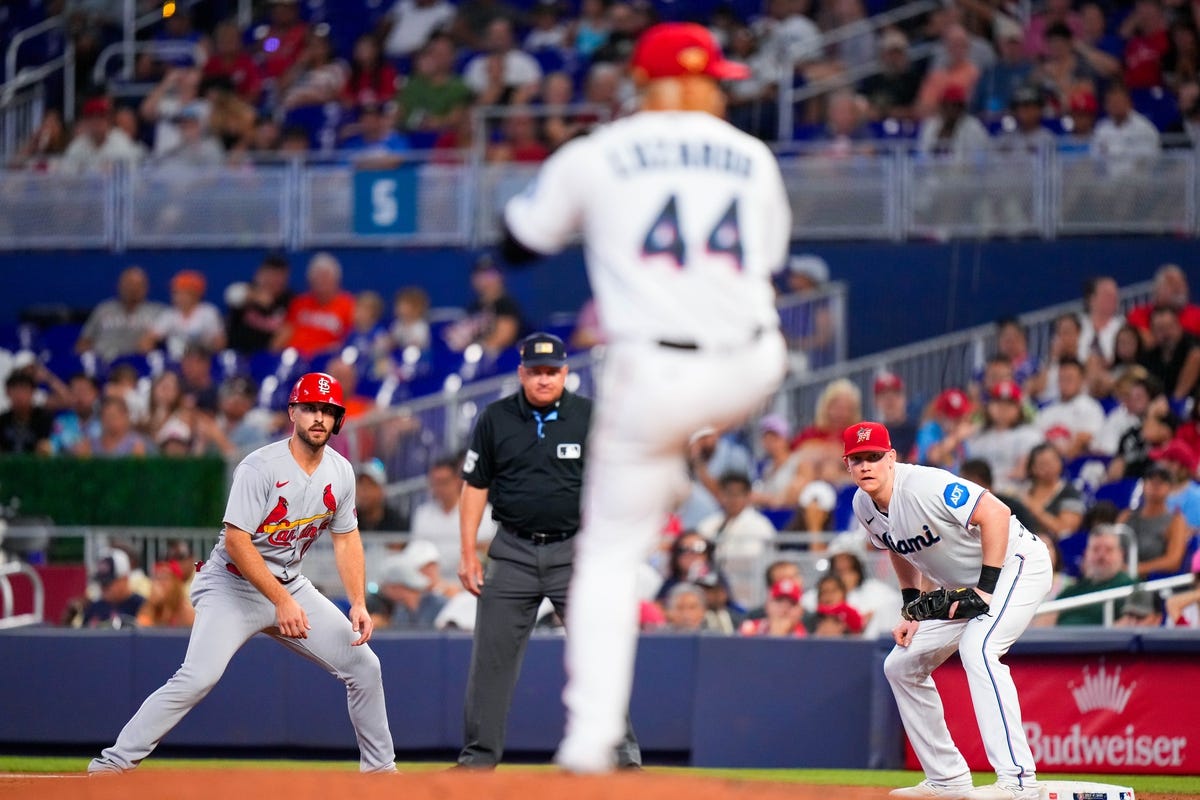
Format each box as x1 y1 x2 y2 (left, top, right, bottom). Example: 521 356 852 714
88 372 396 774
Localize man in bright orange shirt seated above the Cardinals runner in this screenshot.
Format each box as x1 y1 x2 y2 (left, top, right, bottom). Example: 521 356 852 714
271 253 354 359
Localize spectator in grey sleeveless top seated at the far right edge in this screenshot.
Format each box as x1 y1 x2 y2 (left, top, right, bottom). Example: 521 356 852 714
1118 464 1192 579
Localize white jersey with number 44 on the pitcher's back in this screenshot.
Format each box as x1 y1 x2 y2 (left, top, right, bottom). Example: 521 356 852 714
505 112 791 347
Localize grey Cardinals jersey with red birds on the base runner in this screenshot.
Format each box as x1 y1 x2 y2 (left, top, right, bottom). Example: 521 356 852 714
212 439 359 581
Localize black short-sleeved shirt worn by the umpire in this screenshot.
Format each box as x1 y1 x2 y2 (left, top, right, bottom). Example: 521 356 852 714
462 390 592 533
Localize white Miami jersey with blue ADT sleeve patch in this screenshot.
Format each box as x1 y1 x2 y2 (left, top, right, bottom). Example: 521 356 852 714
853 463 1043 588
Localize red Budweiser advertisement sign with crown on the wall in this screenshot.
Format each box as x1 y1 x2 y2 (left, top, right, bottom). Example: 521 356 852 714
907 655 1200 775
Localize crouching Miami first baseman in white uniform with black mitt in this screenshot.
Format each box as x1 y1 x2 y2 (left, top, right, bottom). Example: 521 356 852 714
842 422 1052 800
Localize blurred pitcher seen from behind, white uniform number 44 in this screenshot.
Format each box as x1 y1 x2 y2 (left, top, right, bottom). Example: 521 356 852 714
504 23 791 772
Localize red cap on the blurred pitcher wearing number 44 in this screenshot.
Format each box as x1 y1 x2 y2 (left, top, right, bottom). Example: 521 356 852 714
630 23 750 80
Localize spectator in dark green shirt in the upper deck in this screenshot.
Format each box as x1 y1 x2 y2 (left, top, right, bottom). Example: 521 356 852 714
396 34 473 133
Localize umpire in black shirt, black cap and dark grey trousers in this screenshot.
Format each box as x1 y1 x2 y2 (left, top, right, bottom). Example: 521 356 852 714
458 333 641 769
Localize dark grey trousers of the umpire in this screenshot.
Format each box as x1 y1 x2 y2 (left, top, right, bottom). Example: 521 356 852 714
458 527 642 769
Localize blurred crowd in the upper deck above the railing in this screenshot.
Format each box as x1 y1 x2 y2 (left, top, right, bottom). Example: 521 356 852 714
7 0 1200 170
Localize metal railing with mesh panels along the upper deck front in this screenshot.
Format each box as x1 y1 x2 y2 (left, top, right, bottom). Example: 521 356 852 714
0 142 1200 249
